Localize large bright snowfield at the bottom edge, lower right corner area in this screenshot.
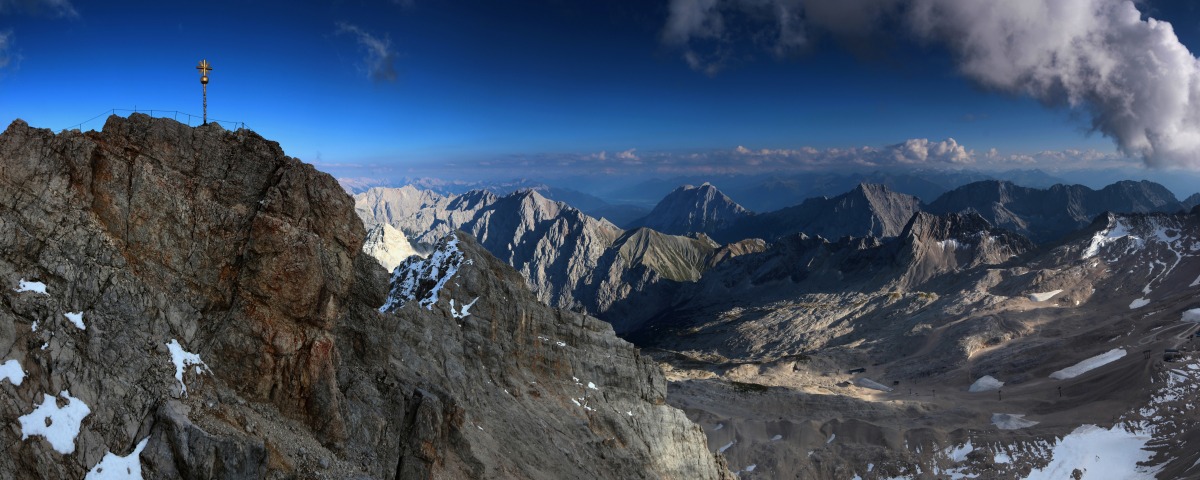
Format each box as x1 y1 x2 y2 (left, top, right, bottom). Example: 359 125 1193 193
1026 424 1157 480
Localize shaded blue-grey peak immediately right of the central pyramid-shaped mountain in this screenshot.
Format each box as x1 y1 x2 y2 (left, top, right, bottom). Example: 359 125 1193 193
714 184 922 246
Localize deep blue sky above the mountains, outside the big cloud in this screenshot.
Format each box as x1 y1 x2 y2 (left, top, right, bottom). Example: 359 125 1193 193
7 0 1200 194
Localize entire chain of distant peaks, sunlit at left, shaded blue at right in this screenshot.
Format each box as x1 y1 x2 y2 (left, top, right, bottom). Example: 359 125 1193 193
355 175 1183 332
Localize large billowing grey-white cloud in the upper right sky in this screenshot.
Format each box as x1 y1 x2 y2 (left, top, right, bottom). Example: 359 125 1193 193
662 0 1200 169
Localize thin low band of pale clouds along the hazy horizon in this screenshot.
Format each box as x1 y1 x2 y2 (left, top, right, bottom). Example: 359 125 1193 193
316 138 1135 185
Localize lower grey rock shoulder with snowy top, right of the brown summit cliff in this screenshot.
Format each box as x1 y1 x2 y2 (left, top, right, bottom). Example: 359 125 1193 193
372 233 721 479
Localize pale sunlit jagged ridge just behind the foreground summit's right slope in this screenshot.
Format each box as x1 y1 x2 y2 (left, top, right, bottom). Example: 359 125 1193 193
355 187 737 331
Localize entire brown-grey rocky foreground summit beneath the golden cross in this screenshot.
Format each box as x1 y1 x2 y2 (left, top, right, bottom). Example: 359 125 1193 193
0 114 730 479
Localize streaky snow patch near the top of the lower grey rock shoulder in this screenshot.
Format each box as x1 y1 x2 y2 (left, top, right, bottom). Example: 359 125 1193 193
379 234 463 312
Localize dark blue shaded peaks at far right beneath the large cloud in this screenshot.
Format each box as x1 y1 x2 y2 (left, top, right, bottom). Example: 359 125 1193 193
926 180 1182 244
